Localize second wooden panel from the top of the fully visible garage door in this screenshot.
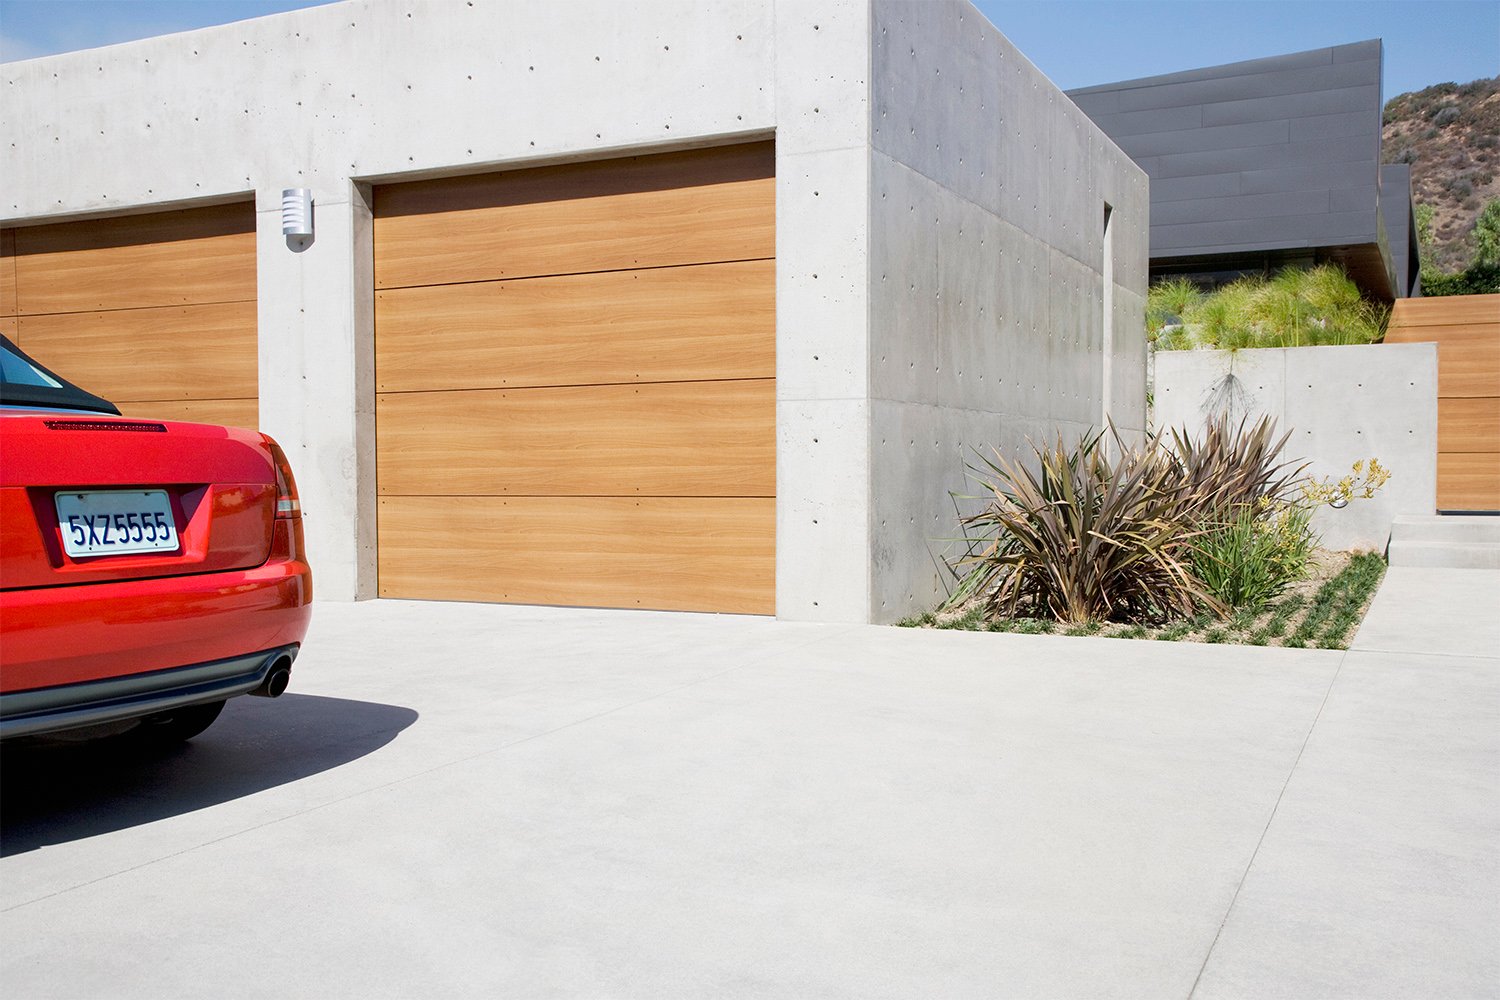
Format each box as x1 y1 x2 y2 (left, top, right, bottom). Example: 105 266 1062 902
375 261 776 393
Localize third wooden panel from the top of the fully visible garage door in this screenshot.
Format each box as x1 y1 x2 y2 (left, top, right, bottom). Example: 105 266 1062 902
375 379 776 496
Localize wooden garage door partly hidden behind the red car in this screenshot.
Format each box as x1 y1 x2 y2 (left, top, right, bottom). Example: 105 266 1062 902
0 202 258 427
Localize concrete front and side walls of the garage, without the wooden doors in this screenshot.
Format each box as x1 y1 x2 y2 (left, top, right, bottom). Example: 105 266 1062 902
0 0 1146 621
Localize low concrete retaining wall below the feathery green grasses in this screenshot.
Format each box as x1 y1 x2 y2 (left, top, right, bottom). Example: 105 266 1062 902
1154 343 1437 552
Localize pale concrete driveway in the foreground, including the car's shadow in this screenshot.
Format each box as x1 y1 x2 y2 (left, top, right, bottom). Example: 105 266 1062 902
0 568 1500 1000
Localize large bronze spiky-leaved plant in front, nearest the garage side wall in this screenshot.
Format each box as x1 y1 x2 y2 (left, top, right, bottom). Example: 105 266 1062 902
948 433 1227 624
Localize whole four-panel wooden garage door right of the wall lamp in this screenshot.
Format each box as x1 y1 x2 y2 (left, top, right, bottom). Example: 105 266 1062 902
375 142 776 613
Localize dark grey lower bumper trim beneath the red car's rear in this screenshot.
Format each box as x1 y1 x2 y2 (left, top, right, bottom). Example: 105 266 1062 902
0 646 297 741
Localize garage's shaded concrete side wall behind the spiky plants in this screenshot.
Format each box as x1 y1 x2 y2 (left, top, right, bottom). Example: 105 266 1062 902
870 0 1149 622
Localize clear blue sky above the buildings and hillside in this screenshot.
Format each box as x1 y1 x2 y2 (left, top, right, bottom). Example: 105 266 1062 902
0 0 1500 97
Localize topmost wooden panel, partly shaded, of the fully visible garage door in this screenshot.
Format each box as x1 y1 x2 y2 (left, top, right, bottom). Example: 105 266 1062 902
374 142 776 289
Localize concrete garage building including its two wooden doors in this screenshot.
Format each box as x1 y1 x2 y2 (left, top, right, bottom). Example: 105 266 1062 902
0 0 1148 622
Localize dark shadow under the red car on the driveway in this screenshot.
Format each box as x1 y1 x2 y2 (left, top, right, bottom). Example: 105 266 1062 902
0 694 417 858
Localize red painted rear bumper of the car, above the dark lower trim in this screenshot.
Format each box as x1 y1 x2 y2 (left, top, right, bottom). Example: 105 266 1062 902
0 559 312 697
